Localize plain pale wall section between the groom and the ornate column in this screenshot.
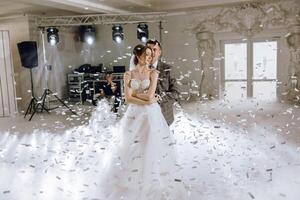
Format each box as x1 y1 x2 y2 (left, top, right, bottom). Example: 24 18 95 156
163 15 200 93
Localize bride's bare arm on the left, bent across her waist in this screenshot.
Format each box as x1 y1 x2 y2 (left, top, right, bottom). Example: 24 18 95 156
124 72 150 105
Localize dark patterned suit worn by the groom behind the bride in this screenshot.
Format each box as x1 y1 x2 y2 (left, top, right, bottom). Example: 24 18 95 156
156 61 179 125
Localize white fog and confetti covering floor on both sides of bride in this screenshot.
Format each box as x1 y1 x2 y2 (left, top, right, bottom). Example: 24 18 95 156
0 101 300 200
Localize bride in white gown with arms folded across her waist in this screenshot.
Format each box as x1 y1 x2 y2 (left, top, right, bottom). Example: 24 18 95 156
103 45 186 200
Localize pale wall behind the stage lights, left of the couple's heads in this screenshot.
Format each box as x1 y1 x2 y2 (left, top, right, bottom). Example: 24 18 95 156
29 24 159 97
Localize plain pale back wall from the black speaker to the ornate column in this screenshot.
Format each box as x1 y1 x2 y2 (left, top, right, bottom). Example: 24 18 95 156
29 16 199 101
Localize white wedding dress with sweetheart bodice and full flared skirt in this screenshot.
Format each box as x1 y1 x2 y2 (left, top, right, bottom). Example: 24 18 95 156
98 79 186 200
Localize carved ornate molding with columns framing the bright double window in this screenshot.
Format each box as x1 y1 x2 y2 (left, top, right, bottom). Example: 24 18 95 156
187 0 300 100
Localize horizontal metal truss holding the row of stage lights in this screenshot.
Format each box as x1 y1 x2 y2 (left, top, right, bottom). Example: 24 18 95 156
36 12 167 27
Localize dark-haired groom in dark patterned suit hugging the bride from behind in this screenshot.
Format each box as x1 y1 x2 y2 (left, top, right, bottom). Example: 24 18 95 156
146 40 179 126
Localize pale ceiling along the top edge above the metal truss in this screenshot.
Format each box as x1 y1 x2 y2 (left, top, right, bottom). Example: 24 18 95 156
0 0 272 16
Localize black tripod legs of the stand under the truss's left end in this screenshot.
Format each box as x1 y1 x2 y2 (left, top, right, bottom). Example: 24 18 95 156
29 89 77 121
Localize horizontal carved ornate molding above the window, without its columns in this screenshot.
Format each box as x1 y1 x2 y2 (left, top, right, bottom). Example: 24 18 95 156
188 0 300 37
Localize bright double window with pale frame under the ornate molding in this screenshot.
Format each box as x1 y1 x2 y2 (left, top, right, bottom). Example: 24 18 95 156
222 41 277 101
